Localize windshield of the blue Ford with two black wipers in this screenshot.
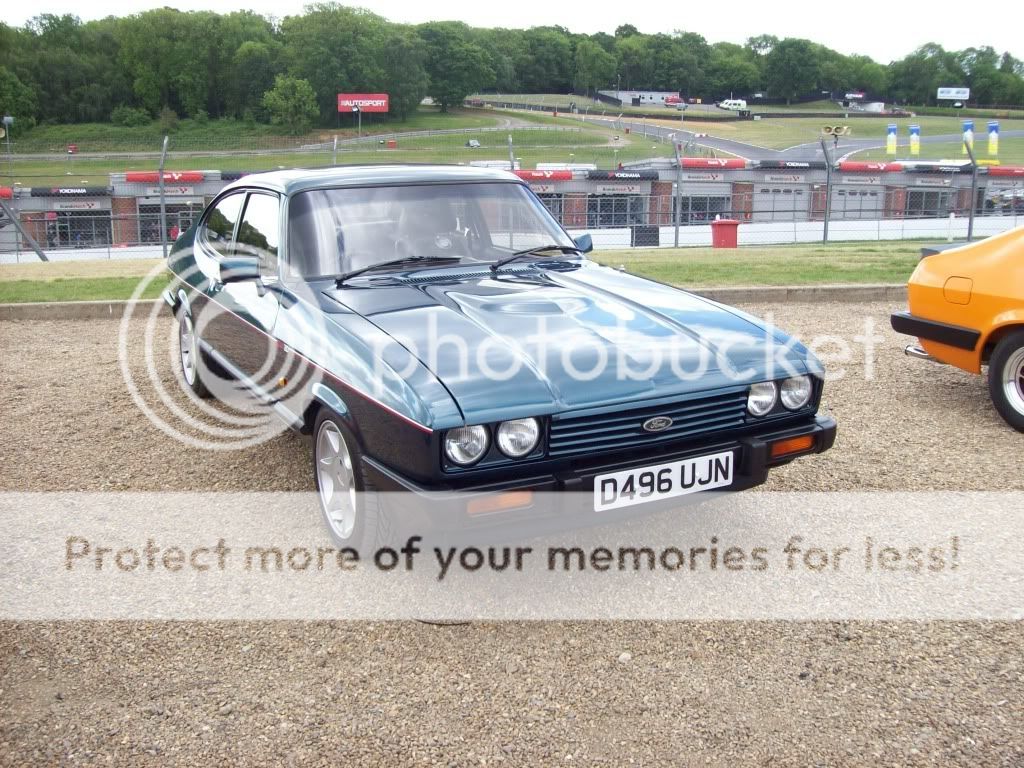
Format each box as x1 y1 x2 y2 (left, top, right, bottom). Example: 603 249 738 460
288 182 574 280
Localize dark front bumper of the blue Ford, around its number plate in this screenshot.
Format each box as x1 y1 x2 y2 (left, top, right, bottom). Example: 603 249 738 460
362 415 836 535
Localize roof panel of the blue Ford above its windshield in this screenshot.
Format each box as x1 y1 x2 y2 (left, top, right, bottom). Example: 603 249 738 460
225 164 523 195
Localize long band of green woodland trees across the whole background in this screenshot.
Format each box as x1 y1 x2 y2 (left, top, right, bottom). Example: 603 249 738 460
0 9 1024 125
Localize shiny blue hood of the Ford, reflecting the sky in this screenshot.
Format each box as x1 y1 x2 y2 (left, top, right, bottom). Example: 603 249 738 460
326 262 820 423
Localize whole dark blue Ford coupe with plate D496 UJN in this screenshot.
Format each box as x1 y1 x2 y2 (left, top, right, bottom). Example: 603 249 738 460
164 166 836 546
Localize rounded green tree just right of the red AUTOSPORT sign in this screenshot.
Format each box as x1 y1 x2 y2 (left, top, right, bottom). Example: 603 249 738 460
419 22 495 112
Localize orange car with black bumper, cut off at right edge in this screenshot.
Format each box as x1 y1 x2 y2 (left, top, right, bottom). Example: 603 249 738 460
892 226 1024 432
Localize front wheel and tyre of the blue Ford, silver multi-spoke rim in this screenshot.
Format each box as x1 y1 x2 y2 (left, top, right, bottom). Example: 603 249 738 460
313 409 388 559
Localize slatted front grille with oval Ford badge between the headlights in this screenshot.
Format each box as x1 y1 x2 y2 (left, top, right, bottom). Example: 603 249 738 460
548 389 746 457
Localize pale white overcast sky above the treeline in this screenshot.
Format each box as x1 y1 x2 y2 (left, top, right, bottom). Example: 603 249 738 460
0 0 1024 63
